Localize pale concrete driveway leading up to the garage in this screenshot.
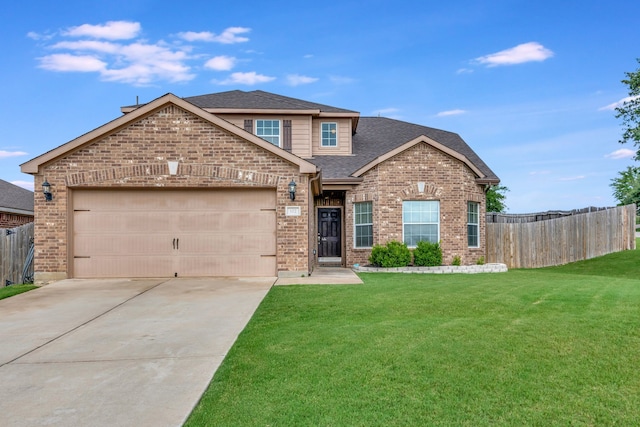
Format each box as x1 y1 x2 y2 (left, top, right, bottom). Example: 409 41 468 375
0 278 275 426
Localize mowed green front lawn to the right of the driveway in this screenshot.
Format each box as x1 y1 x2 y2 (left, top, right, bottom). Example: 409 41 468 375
186 246 640 426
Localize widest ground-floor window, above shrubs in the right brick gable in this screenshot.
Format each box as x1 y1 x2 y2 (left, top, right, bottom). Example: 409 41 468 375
402 200 440 247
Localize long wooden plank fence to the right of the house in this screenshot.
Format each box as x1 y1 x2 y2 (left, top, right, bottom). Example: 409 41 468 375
486 205 636 268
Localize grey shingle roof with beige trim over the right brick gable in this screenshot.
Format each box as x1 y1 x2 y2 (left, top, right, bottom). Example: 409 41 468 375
310 117 500 184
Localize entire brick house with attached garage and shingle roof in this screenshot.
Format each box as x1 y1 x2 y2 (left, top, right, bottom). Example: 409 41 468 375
22 91 499 281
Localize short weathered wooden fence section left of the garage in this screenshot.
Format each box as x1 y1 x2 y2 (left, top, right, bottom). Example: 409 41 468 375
0 222 33 287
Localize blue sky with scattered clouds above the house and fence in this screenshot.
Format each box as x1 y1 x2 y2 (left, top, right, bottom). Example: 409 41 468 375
0 0 640 213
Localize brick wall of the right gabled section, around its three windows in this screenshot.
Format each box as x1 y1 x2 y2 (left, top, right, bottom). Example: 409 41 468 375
345 143 485 266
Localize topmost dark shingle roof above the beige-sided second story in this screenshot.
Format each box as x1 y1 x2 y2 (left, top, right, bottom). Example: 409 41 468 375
183 90 357 114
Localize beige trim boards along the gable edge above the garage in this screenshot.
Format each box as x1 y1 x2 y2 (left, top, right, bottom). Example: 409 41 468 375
20 93 317 174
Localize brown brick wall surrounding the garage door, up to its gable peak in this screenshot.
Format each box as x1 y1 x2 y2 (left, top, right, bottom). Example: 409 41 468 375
34 104 310 280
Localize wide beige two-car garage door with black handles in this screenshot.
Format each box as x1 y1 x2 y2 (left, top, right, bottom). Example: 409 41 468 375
72 189 276 278
